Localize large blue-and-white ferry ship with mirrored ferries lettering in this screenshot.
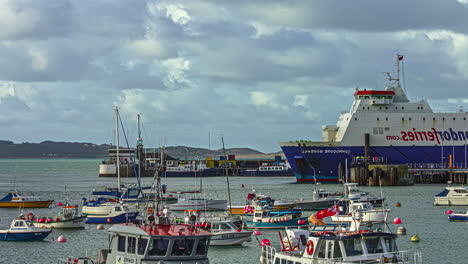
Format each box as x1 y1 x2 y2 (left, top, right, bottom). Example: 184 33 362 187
280 54 468 183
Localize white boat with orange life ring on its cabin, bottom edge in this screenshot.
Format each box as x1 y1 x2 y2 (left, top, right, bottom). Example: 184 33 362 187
260 230 422 264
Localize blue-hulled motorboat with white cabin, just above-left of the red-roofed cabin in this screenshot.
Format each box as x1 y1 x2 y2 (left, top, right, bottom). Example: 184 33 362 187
86 205 138 224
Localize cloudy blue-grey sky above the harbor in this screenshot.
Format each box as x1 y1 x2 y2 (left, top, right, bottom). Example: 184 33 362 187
0 0 468 153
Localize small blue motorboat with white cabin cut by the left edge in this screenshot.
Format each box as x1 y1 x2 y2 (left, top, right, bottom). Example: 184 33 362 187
0 218 52 241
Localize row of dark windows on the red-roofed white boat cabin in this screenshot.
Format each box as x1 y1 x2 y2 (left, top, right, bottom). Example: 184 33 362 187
117 235 208 256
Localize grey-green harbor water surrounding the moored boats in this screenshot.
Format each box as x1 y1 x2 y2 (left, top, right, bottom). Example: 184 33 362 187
0 159 468 264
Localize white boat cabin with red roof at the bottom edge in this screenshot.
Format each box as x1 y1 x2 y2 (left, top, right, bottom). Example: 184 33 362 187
101 224 212 264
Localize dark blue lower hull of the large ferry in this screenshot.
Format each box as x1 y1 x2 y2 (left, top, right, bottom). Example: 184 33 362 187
281 145 468 183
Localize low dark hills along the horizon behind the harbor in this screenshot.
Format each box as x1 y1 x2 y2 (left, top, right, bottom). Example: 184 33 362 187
0 140 281 159
